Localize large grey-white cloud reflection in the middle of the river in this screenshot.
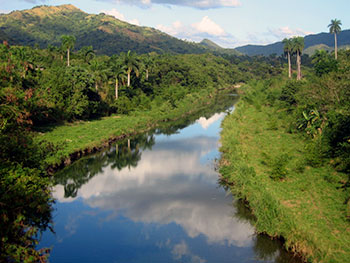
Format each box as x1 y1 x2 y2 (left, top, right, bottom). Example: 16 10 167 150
56 137 253 249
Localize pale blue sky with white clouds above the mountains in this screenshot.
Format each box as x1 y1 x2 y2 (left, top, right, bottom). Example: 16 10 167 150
0 0 350 47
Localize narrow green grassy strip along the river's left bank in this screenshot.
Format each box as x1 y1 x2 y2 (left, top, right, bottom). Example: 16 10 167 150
34 87 235 174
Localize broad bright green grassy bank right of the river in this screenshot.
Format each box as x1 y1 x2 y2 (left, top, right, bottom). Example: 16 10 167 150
220 81 350 263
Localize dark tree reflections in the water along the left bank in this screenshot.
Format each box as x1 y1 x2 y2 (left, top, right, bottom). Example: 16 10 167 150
54 96 236 198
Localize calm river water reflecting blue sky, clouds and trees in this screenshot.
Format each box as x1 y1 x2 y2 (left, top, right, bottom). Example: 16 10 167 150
40 99 296 263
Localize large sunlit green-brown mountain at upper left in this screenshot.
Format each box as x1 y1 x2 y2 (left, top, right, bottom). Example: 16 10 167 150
0 5 210 55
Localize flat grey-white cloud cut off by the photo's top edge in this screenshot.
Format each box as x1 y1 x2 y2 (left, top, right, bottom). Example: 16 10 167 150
100 0 241 9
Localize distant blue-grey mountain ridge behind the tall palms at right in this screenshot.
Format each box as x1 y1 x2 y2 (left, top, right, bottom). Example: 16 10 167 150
236 30 350 56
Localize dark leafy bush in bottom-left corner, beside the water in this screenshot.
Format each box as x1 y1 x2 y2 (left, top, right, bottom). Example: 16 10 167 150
0 163 53 262
